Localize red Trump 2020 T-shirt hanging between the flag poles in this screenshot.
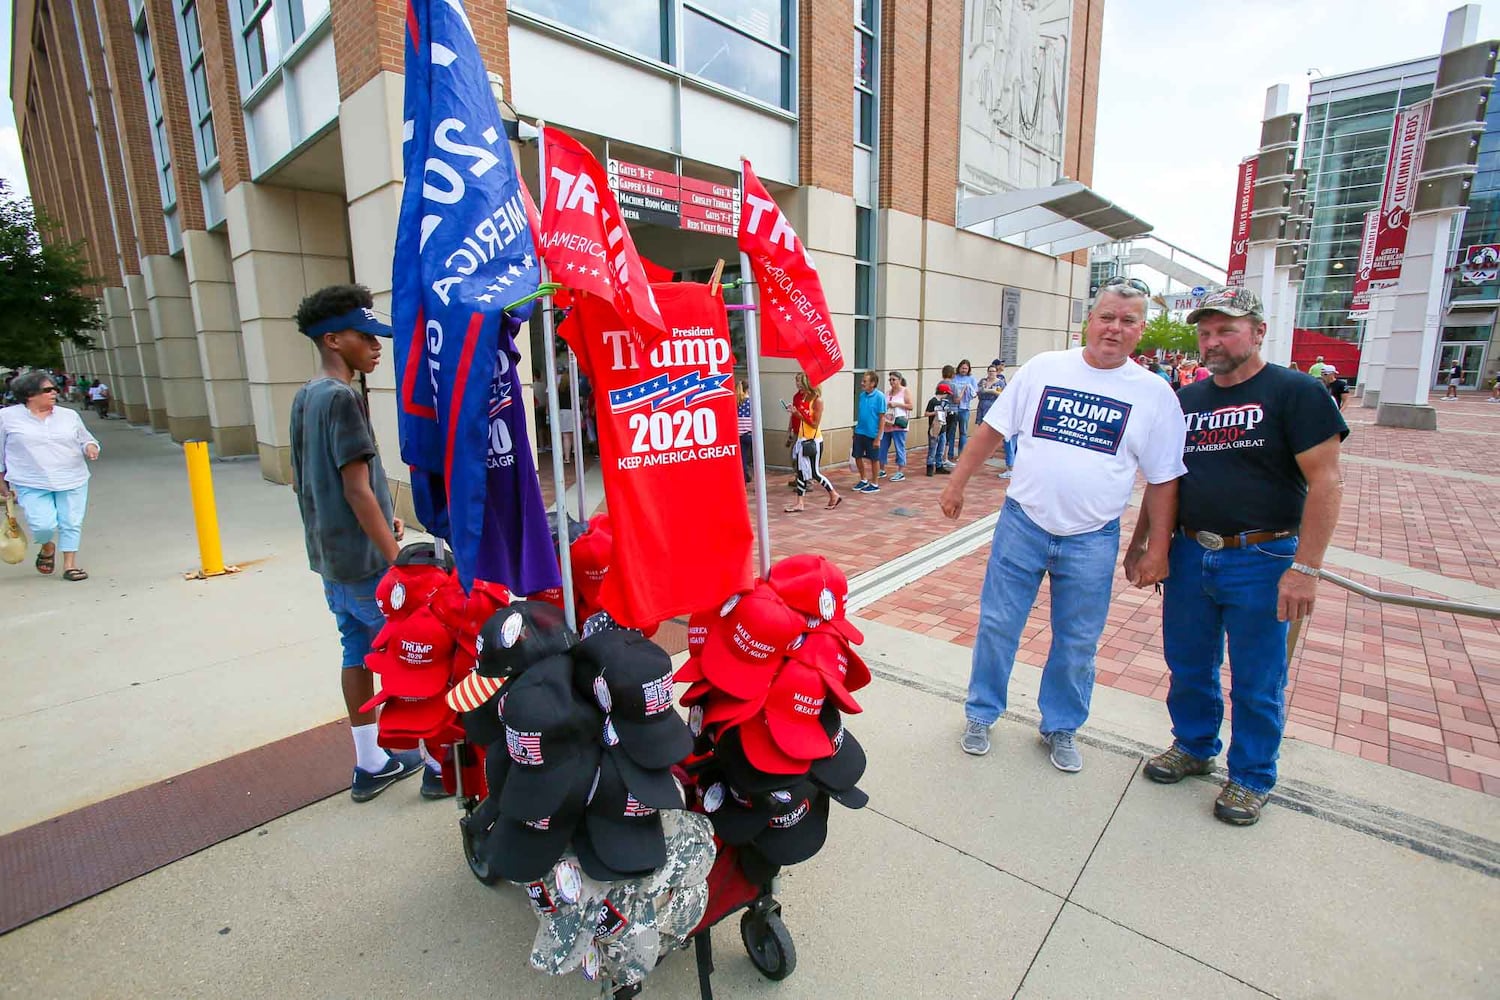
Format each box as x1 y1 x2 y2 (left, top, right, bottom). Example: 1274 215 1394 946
563 283 753 627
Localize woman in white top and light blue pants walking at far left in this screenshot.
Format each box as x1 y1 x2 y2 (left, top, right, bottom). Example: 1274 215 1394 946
0 372 99 582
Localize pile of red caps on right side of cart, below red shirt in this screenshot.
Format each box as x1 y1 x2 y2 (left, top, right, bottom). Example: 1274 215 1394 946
677 555 870 792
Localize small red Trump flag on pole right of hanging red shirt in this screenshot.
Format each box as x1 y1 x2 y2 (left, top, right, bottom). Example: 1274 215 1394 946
740 160 843 385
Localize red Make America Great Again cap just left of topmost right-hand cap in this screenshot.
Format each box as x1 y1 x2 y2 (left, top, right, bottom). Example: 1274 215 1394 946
698 583 807 700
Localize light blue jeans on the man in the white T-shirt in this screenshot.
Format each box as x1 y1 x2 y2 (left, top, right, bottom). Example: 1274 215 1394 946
963 499 1121 733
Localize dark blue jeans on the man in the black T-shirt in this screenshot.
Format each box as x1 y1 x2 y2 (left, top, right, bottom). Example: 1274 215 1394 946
1161 532 1298 793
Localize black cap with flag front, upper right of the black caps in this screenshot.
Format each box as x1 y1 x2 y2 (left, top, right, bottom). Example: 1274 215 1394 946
573 631 693 777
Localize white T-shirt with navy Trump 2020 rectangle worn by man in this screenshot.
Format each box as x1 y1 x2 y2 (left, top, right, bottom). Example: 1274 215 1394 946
984 348 1188 535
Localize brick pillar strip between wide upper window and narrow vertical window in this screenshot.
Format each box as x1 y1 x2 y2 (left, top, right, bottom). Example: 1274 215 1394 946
798 0 854 195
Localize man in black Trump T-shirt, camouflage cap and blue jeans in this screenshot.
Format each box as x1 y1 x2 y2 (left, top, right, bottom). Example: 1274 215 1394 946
1125 288 1349 826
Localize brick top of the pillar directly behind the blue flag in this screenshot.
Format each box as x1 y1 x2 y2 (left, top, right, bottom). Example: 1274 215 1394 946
330 0 510 100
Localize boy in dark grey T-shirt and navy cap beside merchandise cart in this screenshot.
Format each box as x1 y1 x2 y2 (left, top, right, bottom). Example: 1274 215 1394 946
291 285 443 802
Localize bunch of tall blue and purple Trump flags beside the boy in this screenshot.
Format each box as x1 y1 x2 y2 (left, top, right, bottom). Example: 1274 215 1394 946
392 0 560 594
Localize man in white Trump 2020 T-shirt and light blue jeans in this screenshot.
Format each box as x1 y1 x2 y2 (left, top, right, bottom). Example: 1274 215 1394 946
942 277 1187 772
